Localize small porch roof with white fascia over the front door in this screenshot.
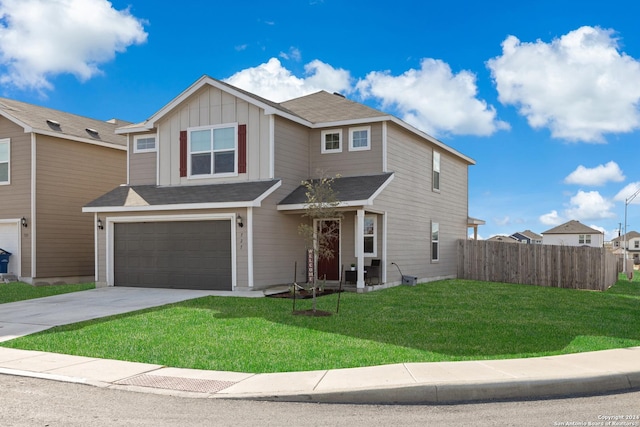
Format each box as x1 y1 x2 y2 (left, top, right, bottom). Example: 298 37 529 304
278 173 394 210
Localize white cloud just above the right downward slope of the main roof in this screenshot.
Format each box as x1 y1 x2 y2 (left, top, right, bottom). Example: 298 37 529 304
357 59 509 136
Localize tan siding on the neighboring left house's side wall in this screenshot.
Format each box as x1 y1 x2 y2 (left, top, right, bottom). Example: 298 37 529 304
34 136 126 278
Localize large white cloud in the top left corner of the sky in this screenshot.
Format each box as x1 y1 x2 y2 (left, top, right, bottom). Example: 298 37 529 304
0 0 147 90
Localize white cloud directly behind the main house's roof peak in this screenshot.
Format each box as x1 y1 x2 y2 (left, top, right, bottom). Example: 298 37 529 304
225 58 351 102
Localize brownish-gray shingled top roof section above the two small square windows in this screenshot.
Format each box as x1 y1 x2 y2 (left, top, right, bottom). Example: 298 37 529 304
280 91 389 123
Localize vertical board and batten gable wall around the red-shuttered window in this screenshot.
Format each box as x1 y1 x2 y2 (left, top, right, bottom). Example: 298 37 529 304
157 86 271 185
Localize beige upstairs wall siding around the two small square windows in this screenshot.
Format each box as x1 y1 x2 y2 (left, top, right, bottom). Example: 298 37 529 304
309 123 383 176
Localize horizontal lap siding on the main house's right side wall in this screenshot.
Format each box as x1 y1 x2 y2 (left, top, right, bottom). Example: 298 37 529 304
375 124 468 282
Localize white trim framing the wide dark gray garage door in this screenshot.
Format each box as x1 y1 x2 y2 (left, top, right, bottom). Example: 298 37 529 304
105 213 237 290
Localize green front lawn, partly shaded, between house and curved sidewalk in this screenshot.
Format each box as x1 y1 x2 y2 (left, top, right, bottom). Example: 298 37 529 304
2 277 640 373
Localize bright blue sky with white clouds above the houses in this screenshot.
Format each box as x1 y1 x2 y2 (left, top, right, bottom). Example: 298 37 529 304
0 0 640 239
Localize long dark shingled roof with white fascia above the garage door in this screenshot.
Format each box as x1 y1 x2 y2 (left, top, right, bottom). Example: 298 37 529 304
82 180 281 212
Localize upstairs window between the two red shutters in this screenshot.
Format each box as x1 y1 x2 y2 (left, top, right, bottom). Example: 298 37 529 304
188 123 238 177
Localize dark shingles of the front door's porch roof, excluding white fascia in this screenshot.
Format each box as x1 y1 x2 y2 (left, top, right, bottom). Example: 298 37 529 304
278 173 393 206
